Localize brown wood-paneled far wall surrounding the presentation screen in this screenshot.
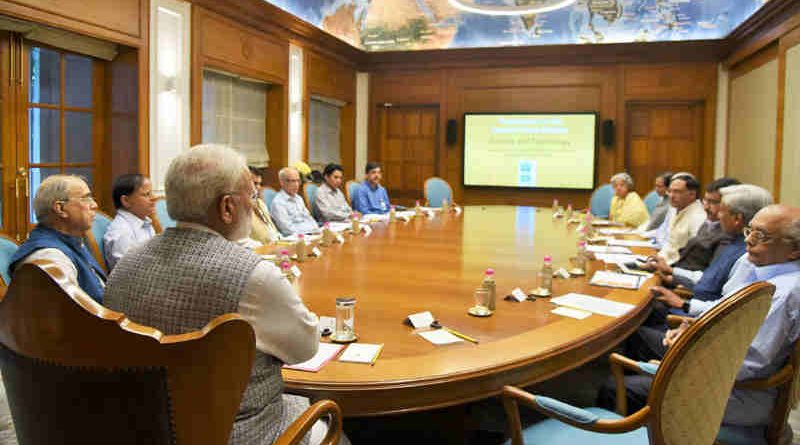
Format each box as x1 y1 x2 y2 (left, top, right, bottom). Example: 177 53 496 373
368 59 717 206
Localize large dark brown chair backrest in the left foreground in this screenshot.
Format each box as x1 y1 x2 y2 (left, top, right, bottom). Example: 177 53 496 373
0 261 255 445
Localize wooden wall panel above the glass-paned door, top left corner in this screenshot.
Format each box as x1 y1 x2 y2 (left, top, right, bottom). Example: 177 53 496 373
0 0 141 46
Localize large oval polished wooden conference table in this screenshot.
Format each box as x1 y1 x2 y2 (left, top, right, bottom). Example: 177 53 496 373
283 206 650 416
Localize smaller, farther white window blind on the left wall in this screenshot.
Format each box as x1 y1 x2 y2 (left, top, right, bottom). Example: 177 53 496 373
308 98 342 170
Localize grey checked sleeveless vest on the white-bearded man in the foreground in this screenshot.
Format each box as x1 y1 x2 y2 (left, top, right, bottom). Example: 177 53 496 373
105 228 308 445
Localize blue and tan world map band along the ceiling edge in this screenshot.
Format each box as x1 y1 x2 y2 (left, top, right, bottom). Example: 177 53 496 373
265 0 768 51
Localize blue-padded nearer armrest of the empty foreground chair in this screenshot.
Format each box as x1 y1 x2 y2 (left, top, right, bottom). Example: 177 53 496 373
502 386 650 445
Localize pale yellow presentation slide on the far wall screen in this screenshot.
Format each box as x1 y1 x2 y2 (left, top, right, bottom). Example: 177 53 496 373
464 113 597 189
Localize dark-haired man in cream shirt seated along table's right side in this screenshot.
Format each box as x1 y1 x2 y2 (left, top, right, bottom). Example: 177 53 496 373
658 173 706 265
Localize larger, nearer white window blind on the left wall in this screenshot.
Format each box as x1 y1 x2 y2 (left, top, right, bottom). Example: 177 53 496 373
203 69 269 167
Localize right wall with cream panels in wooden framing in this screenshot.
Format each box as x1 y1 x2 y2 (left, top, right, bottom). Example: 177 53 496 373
724 7 800 199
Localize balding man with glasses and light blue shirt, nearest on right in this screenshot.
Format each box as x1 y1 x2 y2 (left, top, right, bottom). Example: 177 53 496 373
598 205 800 443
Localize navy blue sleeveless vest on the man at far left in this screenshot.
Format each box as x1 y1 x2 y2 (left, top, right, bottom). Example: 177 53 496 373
8 224 106 304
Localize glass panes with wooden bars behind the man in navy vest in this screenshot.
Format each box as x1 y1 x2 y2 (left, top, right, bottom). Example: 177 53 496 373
28 46 98 223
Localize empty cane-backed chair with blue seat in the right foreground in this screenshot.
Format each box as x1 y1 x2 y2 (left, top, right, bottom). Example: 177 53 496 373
503 282 775 445
